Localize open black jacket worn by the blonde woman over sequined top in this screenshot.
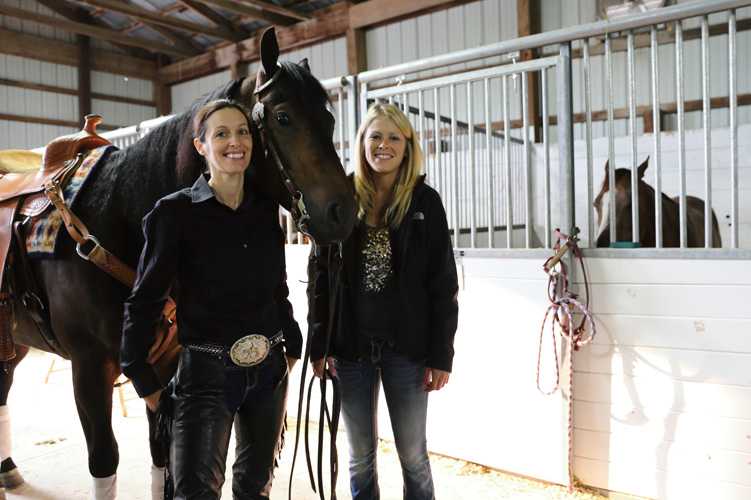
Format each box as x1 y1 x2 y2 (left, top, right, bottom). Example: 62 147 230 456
308 177 459 371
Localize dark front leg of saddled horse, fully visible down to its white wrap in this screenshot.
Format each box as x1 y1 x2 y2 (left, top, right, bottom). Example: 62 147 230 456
71 353 120 500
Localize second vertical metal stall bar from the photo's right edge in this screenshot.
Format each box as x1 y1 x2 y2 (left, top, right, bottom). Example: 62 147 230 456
701 16 712 248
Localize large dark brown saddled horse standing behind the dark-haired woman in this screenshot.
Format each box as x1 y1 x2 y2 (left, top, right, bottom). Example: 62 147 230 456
0 28 355 500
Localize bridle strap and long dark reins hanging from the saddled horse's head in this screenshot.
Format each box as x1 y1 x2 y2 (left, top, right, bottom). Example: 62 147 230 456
251 66 342 500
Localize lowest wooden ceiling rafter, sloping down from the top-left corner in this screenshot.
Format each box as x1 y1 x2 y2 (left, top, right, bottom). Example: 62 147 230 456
0 5 191 57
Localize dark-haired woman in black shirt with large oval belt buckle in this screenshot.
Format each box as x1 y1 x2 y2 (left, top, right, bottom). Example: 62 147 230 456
121 99 302 500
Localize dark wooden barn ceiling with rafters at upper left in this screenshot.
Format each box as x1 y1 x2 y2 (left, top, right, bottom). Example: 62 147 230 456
0 0 338 62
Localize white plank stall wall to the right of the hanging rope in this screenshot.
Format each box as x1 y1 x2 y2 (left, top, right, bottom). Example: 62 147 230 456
574 259 751 500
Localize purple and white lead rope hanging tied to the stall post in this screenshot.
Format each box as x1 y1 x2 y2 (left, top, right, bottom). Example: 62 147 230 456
537 228 597 493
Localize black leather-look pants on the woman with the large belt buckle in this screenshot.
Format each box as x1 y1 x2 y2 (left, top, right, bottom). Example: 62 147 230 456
170 347 287 500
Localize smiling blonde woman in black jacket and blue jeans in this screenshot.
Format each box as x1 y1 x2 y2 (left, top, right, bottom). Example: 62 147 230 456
308 104 458 500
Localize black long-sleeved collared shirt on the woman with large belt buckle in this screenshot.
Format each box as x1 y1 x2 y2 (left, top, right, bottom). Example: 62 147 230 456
121 175 302 396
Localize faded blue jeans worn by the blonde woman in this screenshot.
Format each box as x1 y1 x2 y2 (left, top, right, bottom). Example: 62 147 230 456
335 346 435 500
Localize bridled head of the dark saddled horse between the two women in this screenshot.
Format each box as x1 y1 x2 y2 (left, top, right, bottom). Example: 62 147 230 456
240 28 355 244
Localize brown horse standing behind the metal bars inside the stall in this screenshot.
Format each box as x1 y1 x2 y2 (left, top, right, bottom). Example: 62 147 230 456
593 157 722 248
